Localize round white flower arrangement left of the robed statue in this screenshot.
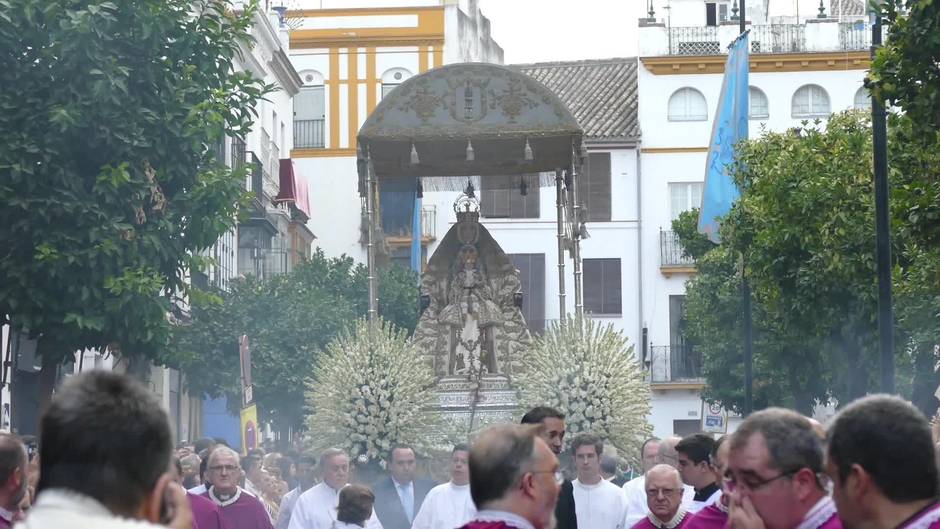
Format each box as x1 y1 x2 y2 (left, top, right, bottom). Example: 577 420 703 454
306 320 437 465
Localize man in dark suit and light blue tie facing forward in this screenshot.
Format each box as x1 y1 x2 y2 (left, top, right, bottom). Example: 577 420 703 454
373 445 437 529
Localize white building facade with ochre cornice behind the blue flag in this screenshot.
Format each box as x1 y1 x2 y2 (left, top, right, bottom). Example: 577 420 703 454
639 0 870 437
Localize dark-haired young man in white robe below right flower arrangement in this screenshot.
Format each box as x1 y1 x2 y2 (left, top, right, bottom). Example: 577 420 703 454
571 433 627 529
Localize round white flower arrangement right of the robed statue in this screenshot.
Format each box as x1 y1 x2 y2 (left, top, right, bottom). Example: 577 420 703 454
517 316 652 460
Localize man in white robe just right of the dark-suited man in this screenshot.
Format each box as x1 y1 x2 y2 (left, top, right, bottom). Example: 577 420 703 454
411 444 477 529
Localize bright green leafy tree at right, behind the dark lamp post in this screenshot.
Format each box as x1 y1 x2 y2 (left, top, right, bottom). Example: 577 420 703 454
673 112 940 412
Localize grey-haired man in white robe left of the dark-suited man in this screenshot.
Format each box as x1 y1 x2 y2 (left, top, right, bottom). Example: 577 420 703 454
288 448 382 529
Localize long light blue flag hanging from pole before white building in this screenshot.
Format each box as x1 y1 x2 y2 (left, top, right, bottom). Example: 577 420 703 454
698 32 748 243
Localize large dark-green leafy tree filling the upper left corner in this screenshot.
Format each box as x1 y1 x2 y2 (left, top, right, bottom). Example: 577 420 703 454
0 0 270 404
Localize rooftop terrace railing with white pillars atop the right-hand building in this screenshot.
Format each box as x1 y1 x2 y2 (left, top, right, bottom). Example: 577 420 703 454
640 19 871 57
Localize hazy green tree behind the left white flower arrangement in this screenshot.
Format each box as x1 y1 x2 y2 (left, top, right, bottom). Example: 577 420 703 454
161 249 418 432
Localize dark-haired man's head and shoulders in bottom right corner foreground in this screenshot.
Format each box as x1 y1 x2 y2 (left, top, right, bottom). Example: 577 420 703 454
826 395 940 529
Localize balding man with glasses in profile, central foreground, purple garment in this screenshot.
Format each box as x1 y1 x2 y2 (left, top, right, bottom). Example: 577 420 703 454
461 424 564 529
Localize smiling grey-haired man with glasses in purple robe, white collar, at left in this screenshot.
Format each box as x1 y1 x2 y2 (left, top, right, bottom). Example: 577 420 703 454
203 446 274 529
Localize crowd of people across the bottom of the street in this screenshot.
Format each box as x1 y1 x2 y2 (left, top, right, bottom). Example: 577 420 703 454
0 371 940 529
